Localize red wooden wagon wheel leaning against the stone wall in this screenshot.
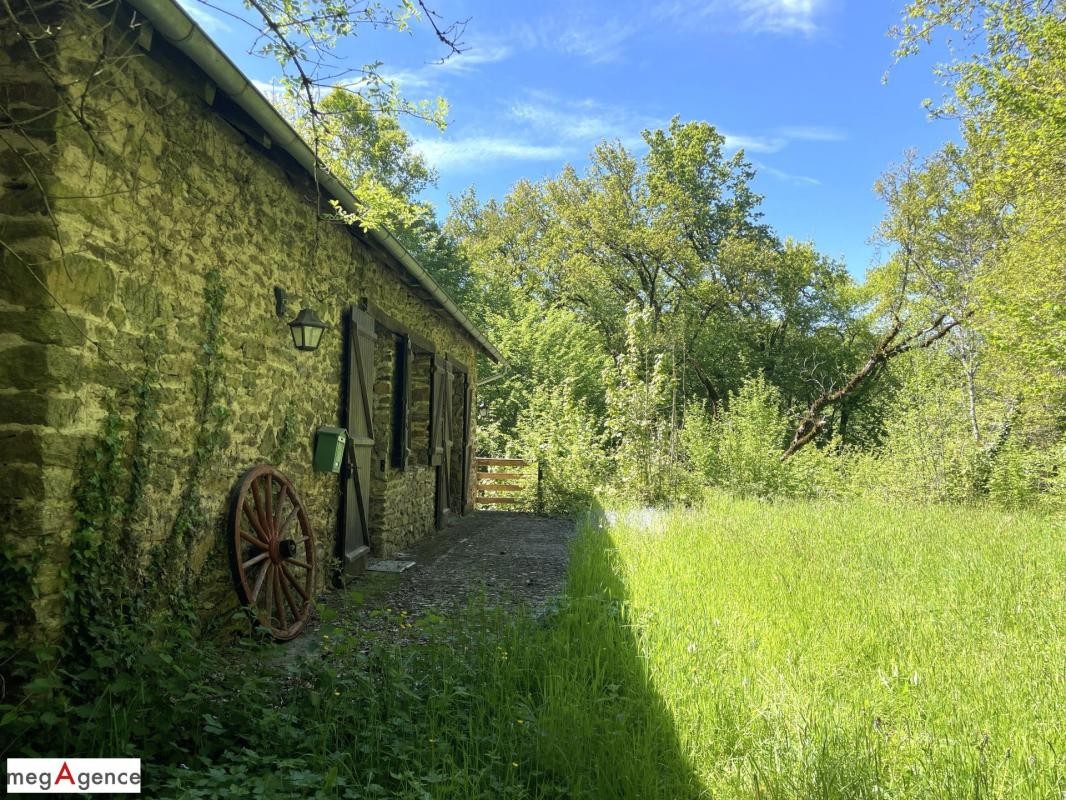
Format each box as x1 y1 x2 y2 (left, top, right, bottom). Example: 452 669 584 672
229 464 314 640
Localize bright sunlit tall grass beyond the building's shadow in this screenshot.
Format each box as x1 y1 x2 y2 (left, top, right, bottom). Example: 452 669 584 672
609 498 1066 800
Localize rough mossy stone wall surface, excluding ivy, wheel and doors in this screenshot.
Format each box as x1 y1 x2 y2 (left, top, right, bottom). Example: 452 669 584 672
0 0 474 633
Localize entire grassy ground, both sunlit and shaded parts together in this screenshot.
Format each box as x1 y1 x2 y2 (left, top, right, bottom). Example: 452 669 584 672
0 499 1066 800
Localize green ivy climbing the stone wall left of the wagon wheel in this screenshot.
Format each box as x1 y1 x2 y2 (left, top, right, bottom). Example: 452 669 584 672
61 270 229 683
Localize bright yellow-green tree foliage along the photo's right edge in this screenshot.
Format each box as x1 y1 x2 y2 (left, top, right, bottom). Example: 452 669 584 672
882 0 1066 486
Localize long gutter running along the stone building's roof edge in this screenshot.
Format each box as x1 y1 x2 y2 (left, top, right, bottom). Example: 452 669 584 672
127 0 503 364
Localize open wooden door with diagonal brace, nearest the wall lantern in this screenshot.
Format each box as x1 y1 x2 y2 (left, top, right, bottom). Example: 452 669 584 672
341 306 377 572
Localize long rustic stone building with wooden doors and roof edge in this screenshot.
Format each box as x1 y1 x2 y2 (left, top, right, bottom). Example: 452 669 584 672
0 0 500 634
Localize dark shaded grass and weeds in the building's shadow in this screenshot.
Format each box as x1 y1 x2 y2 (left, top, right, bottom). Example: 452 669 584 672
4 509 706 800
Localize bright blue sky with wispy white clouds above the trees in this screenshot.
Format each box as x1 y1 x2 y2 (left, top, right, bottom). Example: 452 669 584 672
183 0 955 277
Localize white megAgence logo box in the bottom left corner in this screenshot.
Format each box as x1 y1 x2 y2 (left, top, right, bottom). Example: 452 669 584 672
6 758 141 795
